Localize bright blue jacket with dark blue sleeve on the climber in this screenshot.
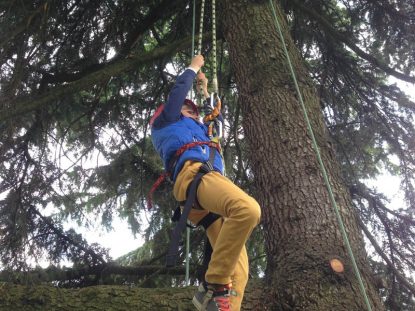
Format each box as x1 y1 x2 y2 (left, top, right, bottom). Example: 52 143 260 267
151 69 223 181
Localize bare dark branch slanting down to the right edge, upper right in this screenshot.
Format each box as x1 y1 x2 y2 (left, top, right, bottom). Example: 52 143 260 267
293 0 415 83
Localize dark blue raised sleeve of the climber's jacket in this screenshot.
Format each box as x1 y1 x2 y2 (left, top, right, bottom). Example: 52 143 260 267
153 69 196 128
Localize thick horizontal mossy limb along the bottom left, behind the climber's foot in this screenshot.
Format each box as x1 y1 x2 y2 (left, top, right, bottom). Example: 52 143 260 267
0 283 261 311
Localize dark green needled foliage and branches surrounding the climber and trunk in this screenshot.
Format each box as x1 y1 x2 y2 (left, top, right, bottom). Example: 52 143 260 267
0 0 415 310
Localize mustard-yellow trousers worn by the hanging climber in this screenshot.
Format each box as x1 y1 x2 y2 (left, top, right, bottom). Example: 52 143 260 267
173 161 261 311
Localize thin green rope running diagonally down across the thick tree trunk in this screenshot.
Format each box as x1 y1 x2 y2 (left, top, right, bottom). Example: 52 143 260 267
269 0 372 311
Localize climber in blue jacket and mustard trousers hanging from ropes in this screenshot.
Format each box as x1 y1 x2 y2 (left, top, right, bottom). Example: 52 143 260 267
150 55 261 311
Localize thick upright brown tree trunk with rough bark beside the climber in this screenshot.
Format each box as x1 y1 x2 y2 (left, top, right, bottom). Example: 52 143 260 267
220 0 383 311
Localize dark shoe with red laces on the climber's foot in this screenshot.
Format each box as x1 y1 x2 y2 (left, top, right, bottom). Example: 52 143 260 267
193 283 231 311
